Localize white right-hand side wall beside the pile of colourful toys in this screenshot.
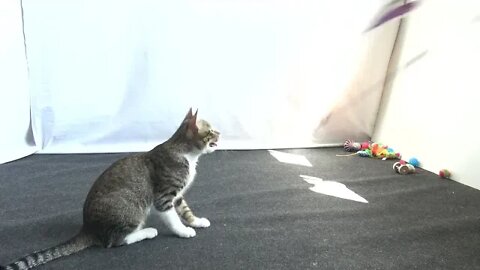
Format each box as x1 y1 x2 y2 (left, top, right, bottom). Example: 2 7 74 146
373 0 480 189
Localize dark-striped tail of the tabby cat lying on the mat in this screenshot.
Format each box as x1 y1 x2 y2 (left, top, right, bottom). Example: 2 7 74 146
0 232 94 270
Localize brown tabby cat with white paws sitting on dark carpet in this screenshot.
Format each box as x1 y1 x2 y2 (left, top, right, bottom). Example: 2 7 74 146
0 109 220 270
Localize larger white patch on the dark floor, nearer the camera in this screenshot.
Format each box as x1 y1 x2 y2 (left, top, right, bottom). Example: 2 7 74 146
300 175 368 203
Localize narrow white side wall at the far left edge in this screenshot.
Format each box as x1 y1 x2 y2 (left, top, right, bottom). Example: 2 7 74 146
0 0 37 164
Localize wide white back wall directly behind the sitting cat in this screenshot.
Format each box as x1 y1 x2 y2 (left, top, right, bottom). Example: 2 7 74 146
20 0 398 153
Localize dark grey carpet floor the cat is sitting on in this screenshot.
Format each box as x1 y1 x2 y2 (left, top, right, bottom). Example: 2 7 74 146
0 148 480 270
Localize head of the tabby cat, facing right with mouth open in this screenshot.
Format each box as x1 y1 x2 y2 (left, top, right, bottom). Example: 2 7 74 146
174 108 220 154
